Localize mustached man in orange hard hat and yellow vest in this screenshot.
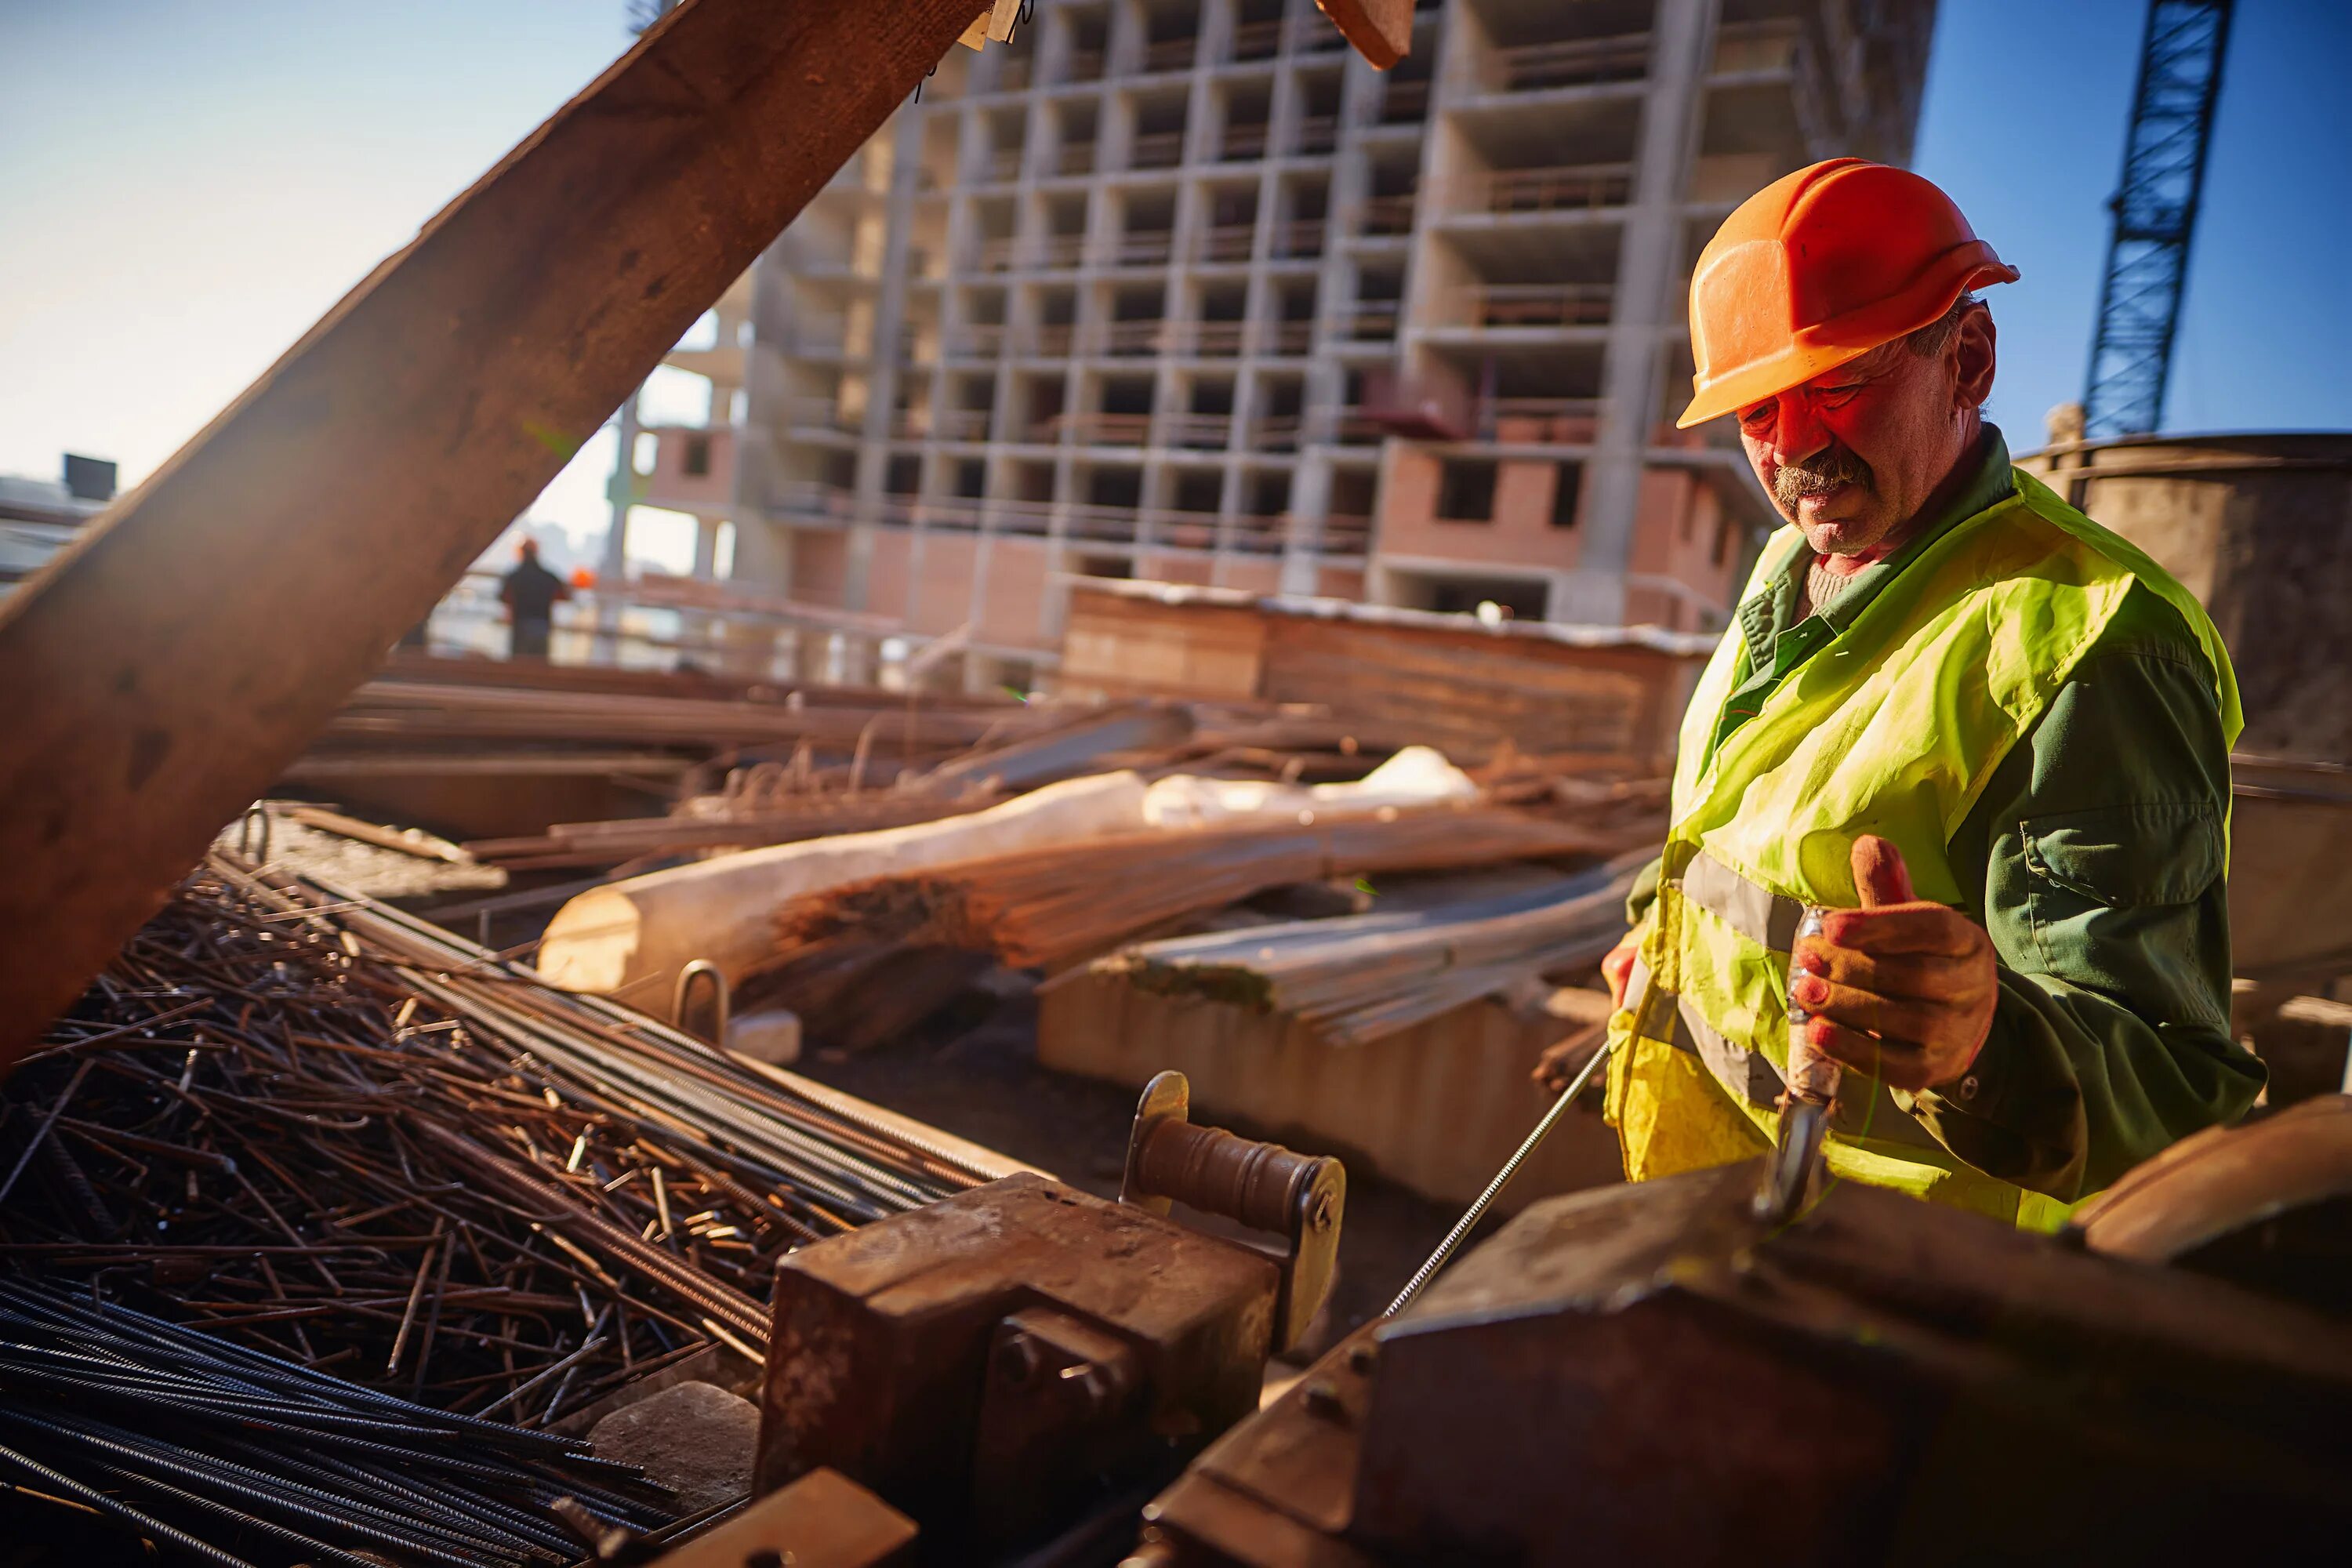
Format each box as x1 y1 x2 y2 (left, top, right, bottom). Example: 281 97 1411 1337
1562 158 2263 1227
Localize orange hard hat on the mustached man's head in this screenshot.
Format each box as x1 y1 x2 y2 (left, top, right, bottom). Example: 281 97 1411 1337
1675 158 2018 430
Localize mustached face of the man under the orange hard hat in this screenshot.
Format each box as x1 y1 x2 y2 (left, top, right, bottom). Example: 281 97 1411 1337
1738 308 1992 555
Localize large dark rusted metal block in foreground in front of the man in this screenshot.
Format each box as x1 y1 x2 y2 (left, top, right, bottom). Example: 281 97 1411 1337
1138 1163 2352 1568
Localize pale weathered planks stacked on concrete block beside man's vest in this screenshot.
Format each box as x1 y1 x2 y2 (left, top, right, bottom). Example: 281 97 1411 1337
1077 848 1651 1046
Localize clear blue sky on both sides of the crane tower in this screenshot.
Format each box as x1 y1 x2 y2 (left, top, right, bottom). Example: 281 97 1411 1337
1912 0 2352 449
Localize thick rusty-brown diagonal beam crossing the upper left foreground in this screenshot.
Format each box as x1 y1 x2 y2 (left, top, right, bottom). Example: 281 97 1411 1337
0 0 974 1069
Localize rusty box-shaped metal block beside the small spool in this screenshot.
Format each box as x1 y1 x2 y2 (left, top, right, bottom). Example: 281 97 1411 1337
753 1175 1282 1544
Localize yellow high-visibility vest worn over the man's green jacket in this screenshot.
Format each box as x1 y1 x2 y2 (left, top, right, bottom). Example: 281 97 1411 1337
1609 473 2244 1229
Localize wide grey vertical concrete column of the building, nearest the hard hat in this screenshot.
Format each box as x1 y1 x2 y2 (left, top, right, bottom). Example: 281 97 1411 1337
1550 0 1722 626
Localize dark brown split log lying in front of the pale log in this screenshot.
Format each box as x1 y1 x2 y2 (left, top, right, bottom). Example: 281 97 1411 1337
746 806 1618 1048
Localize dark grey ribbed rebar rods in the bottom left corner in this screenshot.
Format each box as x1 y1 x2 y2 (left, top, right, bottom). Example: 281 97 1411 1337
0 1279 668 1568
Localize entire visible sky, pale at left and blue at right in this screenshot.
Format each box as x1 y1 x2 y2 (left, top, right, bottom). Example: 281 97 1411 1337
0 0 2352 564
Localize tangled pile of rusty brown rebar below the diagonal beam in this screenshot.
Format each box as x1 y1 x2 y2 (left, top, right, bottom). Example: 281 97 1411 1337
0 855 995 1427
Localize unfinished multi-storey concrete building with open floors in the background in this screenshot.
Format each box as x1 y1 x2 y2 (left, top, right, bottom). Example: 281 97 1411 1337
642 0 1936 687
